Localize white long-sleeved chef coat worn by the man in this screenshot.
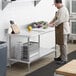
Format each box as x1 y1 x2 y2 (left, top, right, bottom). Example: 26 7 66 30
54 6 70 34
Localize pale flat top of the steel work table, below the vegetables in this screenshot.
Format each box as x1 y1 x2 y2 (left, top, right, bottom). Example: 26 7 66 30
10 27 55 37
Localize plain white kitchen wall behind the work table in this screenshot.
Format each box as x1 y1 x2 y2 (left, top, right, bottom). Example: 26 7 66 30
0 0 56 40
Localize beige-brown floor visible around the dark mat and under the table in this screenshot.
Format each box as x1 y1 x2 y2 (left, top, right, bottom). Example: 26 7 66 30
7 43 76 76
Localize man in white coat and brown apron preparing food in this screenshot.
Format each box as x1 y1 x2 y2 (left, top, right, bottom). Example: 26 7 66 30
49 0 70 64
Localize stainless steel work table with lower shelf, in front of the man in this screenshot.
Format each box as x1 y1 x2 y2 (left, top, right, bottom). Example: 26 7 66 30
9 27 55 71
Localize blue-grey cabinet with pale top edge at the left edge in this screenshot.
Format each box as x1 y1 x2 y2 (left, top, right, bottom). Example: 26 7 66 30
0 41 7 76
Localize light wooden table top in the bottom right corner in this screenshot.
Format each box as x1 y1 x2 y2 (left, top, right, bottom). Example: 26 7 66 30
56 59 76 76
